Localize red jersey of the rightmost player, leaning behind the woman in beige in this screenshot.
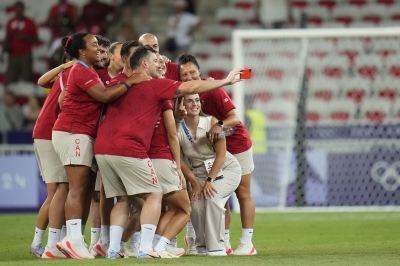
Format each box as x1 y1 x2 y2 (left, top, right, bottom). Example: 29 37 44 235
200 88 252 154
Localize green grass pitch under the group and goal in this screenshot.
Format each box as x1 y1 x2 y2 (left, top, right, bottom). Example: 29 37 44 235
0 212 400 266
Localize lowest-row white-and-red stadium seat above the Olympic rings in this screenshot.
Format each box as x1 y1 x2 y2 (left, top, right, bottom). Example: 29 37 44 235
360 98 391 124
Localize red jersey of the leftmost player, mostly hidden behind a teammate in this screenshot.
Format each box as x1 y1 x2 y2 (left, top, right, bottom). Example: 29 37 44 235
32 68 71 140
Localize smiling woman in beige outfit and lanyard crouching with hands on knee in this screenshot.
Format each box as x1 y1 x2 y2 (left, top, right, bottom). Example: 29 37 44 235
178 94 241 256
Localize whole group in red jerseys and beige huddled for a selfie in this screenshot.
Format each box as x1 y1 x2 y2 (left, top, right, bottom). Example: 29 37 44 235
30 32 257 259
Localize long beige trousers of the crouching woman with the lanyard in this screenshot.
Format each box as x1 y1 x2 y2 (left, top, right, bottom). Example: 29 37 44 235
190 158 242 252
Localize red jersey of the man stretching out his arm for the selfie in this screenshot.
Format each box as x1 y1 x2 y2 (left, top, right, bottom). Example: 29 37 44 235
94 79 182 159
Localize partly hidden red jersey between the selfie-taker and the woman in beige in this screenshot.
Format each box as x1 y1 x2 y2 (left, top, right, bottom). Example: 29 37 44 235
148 100 174 160
